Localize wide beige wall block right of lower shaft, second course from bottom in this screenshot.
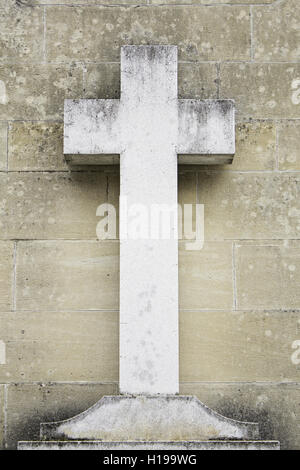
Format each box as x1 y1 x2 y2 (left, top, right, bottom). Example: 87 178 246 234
179 311 300 382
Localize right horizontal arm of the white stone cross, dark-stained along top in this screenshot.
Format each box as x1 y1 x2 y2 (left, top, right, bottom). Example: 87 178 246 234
177 100 235 163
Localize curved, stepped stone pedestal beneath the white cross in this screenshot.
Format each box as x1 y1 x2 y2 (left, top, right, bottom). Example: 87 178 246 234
19 395 279 450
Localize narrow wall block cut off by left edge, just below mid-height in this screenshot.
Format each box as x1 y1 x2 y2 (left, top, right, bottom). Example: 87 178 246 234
0 242 14 312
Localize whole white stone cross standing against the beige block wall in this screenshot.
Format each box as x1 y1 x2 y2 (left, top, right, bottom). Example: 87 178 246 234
64 46 235 395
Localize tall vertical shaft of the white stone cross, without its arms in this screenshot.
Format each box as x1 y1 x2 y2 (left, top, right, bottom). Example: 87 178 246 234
120 46 179 394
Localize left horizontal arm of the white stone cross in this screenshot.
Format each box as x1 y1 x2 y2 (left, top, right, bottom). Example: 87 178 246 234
64 100 122 155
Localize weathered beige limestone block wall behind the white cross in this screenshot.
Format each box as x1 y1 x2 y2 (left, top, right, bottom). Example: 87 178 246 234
0 0 300 449
